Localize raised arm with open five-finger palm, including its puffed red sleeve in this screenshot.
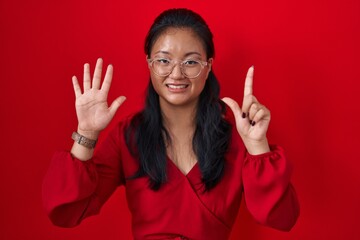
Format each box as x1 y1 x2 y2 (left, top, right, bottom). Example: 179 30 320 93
43 59 125 227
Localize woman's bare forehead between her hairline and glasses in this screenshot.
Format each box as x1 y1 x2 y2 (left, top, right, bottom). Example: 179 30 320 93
151 28 206 57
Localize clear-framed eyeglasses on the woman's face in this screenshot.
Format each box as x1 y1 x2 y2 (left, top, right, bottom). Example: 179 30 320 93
147 58 208 78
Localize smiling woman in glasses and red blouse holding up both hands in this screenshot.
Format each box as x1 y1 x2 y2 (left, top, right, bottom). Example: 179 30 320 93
43 9 299 240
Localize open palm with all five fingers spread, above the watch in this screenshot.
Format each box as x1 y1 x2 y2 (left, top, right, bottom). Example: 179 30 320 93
72 58 126 139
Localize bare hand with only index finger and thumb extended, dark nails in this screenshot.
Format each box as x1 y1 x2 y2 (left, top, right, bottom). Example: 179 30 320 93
222 67 270 155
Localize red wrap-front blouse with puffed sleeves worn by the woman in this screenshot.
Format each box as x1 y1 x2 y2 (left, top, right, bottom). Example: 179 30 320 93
43 115 299 240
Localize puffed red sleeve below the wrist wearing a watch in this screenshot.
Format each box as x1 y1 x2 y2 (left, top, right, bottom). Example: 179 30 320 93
42 123 124 227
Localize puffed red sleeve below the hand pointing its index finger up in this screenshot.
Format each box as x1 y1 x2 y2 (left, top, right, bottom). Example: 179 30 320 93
243 145 299 231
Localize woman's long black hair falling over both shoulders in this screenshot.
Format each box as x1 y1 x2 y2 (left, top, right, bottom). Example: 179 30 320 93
125 9 231 191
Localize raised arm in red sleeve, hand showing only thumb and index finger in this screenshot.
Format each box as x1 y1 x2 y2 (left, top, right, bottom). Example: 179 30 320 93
223 67 299 230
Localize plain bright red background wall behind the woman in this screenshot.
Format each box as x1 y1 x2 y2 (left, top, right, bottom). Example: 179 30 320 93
0 0 360 240
